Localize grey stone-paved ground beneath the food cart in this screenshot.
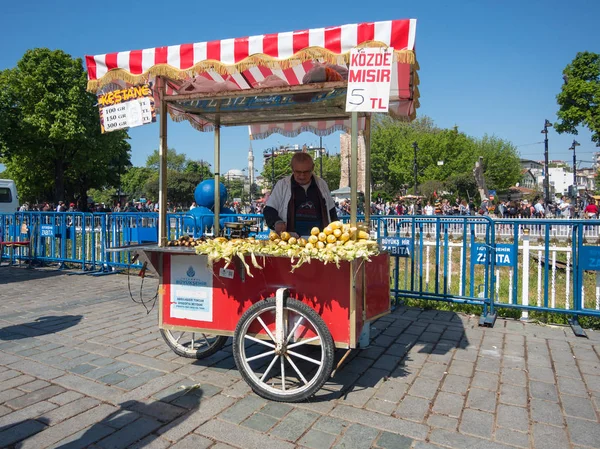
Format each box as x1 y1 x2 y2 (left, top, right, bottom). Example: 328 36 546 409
0 266 600 449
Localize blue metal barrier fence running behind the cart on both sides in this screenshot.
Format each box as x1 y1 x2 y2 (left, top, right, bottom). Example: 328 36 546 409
0 212 600 324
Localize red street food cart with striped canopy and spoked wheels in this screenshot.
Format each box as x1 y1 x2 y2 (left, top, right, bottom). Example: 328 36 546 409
86 19 419 402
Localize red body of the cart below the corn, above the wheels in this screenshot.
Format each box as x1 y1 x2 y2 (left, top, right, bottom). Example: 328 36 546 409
154 251 390 348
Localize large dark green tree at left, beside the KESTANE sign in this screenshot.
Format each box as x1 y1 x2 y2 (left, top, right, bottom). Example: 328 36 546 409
0 48 130 204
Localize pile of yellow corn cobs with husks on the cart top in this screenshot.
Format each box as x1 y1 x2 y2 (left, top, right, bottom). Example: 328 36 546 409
195 221 379 276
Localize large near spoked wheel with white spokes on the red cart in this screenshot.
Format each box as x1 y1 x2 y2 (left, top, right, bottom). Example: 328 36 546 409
233 289 335 402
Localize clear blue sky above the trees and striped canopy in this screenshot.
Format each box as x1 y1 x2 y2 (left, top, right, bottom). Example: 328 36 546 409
0 0 600 172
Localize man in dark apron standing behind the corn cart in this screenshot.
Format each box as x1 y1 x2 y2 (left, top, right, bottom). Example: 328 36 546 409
263 153 338 236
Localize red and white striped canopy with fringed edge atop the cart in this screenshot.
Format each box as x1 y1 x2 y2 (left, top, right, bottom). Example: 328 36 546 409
86 19 419 138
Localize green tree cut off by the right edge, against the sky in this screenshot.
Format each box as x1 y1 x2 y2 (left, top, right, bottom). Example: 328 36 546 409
555 51 600 145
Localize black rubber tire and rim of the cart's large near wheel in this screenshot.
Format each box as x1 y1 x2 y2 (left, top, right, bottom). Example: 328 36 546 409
233 298 335 402
